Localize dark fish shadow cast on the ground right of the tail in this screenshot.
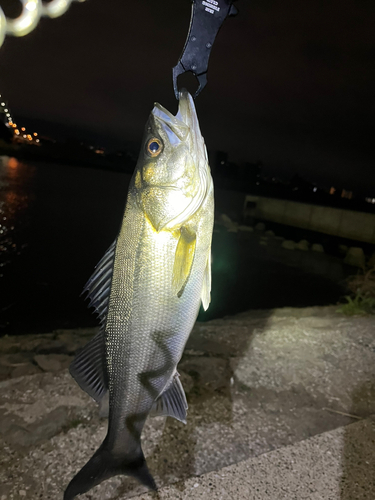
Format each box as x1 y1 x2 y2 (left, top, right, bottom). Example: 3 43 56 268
142 311 272 487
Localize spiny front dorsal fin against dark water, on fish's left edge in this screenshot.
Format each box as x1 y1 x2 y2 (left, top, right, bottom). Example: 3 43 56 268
82 240 117 327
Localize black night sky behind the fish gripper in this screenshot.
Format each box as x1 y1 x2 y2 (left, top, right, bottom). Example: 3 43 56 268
0 0 375 196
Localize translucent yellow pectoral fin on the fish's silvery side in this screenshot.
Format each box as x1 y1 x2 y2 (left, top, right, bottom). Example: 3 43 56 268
172 227 197 297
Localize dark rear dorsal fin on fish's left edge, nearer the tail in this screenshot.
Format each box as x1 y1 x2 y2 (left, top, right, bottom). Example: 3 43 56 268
69 328 108 402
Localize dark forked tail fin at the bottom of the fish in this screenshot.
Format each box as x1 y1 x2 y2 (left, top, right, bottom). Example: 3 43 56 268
64 441 157 500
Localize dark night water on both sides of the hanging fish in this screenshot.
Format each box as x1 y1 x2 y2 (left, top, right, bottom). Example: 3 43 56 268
0 157 343 335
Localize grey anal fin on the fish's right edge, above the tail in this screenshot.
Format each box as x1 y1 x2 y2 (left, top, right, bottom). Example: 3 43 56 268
151 372 188 424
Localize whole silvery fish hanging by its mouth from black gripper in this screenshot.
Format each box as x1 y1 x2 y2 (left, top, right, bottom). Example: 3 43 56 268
64 90 214 500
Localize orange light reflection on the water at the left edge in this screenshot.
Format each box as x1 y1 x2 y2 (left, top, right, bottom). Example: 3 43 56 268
0 156 35 278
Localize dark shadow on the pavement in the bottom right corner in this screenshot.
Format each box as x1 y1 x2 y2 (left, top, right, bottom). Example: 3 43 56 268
340 380 375 500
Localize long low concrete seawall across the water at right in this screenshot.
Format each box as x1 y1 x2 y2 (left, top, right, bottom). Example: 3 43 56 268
243 195 375 244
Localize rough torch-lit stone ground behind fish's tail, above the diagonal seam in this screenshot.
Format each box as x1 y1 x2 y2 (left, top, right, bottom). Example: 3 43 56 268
0 306 375 500
